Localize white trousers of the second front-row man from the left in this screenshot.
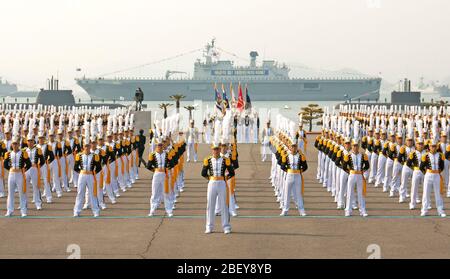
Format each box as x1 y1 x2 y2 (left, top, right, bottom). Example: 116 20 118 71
73 174 100 216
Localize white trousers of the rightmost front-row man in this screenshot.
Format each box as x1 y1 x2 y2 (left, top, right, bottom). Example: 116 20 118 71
422 173 444 217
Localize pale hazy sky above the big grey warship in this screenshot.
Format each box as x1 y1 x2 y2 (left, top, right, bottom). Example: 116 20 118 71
0 0 450 94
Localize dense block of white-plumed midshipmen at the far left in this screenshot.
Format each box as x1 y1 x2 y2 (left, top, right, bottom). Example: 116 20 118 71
0 105 146 217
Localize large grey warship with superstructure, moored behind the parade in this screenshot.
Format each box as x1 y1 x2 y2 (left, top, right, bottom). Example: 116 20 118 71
75 40 381 101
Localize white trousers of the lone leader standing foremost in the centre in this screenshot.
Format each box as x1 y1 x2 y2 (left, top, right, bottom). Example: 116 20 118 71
206 180 231 231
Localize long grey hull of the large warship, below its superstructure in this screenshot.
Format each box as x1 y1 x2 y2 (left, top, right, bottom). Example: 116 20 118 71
77 78 381 101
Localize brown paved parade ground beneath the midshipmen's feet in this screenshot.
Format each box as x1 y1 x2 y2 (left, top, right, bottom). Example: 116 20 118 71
0 136 450 258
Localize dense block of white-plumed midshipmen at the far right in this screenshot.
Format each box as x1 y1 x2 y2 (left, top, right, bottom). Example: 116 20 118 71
315 105 450 217
